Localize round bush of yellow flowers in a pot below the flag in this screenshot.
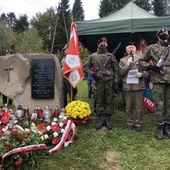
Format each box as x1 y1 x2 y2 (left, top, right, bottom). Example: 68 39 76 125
65 100 91 124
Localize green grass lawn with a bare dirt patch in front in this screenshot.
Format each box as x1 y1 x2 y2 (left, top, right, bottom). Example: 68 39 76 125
1 80 170 170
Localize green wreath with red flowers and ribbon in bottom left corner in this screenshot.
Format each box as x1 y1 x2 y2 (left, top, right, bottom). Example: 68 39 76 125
0 127 47 170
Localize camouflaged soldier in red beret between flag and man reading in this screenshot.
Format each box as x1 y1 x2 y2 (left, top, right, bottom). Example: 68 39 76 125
84 37 118 130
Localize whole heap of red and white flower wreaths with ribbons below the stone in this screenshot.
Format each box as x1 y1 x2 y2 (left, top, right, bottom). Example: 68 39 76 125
0 108 76 170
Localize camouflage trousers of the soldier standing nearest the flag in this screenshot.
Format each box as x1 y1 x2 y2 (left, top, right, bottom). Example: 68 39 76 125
94 80 114 115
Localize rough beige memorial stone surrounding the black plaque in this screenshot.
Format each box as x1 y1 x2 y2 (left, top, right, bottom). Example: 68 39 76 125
0 54 63 112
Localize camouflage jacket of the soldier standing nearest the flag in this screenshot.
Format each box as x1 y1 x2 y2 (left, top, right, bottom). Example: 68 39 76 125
84 49 118 83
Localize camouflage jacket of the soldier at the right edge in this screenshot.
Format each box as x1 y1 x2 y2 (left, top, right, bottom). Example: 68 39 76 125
143 41 170 83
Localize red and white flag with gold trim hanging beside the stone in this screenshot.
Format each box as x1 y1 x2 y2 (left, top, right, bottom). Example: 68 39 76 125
63 22 84 88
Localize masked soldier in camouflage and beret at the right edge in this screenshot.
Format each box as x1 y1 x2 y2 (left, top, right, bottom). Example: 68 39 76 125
144 27 170 139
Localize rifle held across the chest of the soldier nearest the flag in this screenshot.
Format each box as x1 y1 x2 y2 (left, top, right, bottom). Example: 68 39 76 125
97 42 122 77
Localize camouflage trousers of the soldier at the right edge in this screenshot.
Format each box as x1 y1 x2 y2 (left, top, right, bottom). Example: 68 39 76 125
153 84 170 124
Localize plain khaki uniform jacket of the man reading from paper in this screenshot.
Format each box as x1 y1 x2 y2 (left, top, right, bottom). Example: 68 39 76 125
119 54 148 91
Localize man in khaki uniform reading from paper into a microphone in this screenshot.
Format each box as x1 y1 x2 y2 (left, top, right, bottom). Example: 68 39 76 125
119 42 148 132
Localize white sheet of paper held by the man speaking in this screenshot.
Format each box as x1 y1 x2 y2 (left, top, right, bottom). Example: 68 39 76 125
126 69 139 84
